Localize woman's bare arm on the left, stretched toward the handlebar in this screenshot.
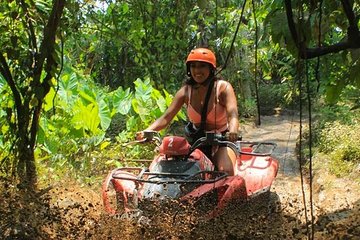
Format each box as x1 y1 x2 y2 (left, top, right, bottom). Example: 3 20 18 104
145 85 187 131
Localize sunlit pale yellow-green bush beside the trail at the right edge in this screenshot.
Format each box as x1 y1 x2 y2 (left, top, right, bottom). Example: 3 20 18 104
313 101 360 177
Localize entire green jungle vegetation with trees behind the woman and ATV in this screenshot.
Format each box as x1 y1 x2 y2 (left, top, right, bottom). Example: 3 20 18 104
0 0 360 186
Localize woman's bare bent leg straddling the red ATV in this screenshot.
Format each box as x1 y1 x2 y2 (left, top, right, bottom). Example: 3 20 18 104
213 147 236 176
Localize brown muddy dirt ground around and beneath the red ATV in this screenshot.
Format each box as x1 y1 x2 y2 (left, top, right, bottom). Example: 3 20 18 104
0 114 360 240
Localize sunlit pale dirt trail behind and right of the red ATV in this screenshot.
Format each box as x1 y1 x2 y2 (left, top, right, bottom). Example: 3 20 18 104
242 114 360 239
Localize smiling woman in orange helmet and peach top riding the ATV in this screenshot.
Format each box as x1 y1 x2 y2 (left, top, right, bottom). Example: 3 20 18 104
137 48 239 176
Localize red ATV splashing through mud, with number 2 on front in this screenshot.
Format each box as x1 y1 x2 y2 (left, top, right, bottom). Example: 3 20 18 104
102 131 278 218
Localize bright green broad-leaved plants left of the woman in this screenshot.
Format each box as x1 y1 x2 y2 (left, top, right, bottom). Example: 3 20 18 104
37 68 185 175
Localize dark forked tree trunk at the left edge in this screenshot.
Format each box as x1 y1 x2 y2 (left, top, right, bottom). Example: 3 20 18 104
0 0 66 189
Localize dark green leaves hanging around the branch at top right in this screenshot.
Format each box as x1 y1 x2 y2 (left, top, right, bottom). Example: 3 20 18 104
265 1 360 104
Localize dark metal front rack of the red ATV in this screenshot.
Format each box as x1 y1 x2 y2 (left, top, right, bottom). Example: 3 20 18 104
112 167 228 184
